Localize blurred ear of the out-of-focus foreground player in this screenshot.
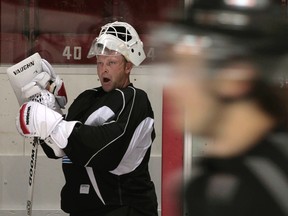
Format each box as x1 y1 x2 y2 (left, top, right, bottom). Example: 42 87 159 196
213 64 257 99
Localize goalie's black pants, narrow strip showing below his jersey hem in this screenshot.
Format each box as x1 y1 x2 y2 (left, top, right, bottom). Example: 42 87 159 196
70 206 143 216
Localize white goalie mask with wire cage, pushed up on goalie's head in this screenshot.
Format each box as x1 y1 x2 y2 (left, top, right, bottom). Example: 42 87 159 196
87 21 146 66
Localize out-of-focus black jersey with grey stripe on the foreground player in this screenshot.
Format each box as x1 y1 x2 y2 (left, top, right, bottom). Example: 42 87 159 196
185 129 288 216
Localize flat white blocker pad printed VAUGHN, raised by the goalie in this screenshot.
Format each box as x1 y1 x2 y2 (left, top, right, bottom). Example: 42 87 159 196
7 53 42 105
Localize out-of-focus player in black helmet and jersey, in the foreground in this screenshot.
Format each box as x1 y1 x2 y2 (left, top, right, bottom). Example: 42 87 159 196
155 0 288 216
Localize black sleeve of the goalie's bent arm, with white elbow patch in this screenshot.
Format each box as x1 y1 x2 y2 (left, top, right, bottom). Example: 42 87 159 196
64 88 155 170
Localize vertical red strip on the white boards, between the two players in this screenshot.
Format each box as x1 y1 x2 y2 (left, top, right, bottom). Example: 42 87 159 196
161 90 183 216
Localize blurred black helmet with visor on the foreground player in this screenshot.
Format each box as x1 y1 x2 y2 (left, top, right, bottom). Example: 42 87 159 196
153 0 288 77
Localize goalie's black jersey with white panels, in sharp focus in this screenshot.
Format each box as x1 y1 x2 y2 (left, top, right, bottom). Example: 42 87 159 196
42 85 157 216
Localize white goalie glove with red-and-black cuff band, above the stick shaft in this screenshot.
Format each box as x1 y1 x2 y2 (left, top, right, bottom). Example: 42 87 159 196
16 101 79 156
